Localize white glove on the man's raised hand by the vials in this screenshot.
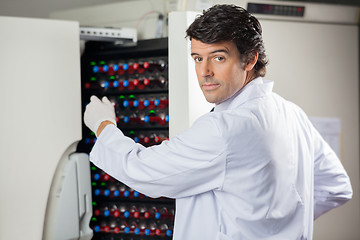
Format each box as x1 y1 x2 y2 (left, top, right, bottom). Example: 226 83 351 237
84 96 116 134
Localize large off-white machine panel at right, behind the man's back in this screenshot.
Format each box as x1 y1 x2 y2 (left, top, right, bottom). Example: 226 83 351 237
261 17 360 240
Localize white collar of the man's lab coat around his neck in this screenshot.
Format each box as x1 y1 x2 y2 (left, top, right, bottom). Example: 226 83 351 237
214 77 274 112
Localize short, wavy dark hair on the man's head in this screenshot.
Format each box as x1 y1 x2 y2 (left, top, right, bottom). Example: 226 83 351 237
186 4 268 77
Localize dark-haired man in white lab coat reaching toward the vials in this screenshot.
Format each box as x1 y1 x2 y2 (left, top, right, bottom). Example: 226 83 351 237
85 5 352 240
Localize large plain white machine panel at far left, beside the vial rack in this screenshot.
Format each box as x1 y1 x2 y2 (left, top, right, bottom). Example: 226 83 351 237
0 17 81 240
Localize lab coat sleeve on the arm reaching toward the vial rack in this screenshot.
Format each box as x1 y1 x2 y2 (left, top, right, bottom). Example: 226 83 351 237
90 114 226 198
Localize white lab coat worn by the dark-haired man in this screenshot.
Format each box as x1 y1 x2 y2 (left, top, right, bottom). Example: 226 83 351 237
90 78 352 240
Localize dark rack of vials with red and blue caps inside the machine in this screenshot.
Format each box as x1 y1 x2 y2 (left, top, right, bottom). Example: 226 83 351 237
78 39 175 240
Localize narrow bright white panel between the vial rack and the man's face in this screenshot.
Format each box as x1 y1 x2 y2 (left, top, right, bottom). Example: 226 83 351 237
169 12 214 138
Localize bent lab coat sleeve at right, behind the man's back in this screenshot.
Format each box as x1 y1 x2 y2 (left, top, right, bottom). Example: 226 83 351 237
312 124 352 219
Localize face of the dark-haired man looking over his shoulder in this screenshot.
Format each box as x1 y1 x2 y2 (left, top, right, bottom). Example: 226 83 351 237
191 39 246 104
